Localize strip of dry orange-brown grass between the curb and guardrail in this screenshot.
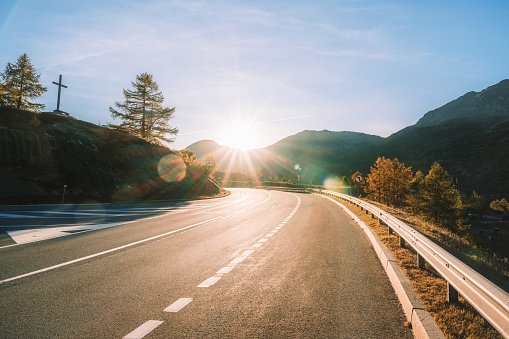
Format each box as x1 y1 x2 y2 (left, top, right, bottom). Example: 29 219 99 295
341 200 502 339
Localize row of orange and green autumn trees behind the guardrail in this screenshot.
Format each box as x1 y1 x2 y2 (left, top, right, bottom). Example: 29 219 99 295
351 157 509 229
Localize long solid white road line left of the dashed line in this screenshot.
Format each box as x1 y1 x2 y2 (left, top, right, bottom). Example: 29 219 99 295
0 194 272 284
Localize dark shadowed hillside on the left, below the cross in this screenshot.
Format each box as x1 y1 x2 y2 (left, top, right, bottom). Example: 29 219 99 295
0 108 219 204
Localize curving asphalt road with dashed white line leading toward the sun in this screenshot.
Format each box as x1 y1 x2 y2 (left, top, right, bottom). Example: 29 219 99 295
0 189 412 338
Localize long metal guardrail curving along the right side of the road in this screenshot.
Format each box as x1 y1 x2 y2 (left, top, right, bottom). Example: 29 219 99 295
314 190 509 338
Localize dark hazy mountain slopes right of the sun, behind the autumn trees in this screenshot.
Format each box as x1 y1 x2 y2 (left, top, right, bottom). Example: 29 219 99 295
189 80 509 197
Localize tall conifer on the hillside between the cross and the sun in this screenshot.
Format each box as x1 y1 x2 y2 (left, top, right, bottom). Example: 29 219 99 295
109 73 178 142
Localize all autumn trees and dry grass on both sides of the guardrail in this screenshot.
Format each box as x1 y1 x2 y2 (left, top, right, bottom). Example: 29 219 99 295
328 157 509 338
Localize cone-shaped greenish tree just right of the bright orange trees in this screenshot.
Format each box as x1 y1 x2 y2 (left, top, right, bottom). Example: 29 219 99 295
418 162 462 228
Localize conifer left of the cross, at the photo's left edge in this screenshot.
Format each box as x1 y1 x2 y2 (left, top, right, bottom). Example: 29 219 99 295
0 53 47 113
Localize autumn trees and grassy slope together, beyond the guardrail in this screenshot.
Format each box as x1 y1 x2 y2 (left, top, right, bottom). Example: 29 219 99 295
352 157 509 278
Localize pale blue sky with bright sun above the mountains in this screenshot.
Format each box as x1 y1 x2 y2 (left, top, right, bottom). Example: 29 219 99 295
0 0 509 149
